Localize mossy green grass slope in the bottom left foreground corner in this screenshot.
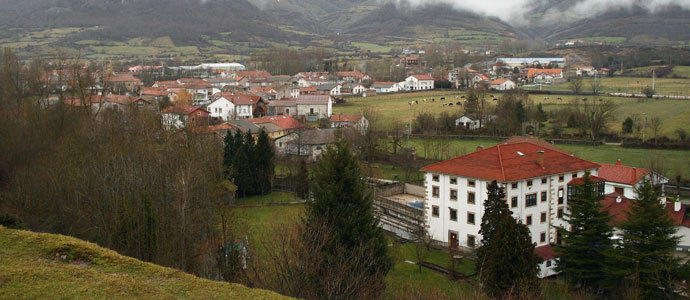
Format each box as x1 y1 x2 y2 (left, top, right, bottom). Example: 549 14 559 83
0 226 285 299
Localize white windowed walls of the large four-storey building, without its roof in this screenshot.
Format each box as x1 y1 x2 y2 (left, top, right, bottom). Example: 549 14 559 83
425 169 597 277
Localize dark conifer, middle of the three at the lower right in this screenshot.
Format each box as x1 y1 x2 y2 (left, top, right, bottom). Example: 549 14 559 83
556 175 617 290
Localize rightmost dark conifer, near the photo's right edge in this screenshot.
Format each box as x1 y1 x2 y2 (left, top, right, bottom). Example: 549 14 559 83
620 181 680 299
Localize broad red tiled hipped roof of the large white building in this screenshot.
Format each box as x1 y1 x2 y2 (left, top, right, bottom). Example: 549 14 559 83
422 142 599 182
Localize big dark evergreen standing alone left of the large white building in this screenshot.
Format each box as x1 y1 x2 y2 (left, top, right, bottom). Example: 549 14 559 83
304 140 392 293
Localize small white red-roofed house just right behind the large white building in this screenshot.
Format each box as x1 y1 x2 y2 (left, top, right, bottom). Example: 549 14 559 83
598 160 669 199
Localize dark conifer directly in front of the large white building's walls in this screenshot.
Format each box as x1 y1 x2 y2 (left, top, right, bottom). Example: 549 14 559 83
477 181 540 298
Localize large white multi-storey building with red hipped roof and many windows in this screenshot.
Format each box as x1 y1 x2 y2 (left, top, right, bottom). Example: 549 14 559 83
422 139 600 277
